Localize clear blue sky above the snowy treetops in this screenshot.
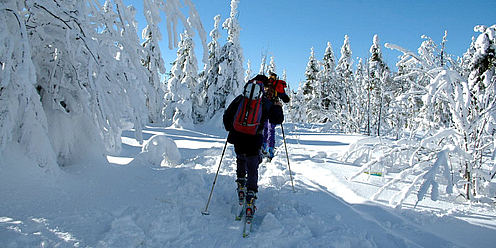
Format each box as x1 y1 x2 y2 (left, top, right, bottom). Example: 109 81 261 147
124 0 496 89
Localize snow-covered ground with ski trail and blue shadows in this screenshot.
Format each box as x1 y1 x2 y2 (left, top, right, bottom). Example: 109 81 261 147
0 124 496 247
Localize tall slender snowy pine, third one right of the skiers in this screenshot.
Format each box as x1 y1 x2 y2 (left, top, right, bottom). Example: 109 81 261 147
334 35 359 132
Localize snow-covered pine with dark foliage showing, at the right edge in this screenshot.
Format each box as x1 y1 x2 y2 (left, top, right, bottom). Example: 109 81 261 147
464 25 496 198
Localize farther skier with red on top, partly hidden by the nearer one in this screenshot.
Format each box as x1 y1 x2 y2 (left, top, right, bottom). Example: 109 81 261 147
262 72 289 161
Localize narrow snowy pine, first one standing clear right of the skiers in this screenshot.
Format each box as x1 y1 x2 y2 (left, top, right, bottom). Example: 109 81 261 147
301 47 322 122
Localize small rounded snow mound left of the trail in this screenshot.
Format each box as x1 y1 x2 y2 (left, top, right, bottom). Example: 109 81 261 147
139 134 181 167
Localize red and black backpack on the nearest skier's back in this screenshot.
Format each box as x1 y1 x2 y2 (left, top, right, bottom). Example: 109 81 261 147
234 80 263 135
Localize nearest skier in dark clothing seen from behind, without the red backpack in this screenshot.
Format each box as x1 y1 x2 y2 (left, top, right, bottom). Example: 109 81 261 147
223 75 282 217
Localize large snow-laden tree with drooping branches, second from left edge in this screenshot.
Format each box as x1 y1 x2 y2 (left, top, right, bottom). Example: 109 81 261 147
25 1 148 165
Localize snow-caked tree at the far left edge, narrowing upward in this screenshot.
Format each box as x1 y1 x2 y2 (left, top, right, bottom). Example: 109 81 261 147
0 0 57 171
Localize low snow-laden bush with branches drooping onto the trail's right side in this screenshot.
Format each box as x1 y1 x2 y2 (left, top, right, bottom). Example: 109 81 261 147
344 129 469 206
